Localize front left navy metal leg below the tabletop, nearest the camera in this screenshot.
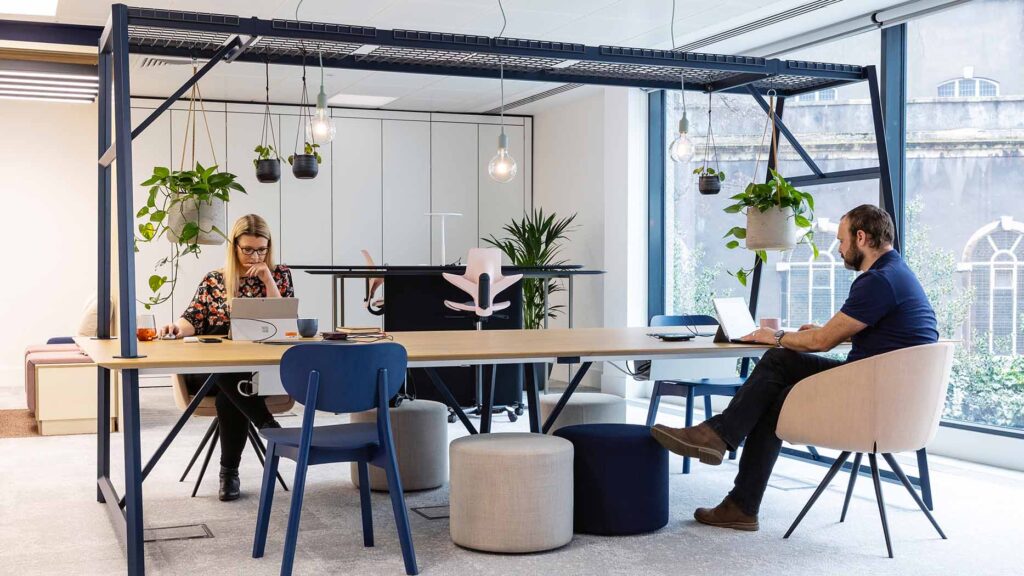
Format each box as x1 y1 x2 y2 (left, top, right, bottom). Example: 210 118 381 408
121 370 145 576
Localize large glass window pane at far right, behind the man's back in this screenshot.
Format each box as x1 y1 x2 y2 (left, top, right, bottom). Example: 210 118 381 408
906 0 1024 428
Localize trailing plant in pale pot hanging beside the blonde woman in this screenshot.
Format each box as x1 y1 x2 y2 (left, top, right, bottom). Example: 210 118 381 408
135 66 246 308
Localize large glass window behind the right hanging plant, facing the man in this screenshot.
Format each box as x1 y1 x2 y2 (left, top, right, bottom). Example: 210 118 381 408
665 32 881 326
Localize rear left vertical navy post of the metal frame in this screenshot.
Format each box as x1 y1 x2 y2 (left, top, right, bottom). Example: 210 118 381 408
96 46 111 502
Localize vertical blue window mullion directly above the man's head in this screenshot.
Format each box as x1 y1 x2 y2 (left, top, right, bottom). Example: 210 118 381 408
880 24 906 250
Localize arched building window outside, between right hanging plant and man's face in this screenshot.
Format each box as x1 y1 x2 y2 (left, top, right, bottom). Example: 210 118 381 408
775 218 856 327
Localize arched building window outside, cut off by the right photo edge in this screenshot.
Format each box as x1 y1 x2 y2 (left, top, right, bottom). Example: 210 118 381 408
958 216 1024 356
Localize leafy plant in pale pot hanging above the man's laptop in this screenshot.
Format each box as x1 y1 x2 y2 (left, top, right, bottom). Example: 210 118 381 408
724 92 818 286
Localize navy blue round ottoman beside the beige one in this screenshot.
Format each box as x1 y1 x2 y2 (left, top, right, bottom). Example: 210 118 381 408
554 424 669 535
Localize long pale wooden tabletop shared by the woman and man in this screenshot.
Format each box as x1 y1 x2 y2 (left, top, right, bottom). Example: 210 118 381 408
76 328 771 370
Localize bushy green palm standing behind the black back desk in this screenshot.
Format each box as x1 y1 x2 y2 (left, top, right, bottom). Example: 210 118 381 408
481 209 577 330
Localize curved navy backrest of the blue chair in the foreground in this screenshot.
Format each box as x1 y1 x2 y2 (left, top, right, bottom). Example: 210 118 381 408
281 342 409 413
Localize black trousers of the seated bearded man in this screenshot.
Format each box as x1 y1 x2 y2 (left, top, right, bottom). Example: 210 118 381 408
708 348 843 516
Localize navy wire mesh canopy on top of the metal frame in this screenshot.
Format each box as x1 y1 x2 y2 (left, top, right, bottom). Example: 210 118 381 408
128 8 865 96
